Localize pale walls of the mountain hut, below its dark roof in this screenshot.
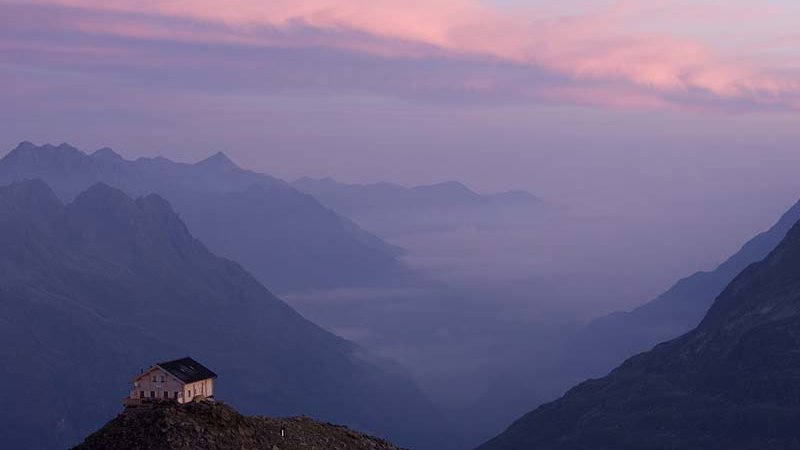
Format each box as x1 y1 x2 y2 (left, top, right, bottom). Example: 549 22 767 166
131 367 214 403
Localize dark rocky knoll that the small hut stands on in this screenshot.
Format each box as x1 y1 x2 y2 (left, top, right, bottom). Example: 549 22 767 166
74 401 400 450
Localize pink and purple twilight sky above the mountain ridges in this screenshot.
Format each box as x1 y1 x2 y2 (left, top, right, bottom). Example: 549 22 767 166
0 0 800 310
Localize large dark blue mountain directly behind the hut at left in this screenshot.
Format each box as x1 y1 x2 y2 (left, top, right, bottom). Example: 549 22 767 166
0 179 450 449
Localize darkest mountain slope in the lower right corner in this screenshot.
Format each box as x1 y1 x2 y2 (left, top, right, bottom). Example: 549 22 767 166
479 215 800 450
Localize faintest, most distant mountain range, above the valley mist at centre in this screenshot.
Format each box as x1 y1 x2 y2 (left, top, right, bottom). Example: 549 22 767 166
292 178 543 237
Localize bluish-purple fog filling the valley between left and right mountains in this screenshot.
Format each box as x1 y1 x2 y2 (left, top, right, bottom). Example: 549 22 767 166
284 196 789 437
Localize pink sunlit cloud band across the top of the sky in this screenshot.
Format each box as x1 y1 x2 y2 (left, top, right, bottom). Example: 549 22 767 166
10 0 800 106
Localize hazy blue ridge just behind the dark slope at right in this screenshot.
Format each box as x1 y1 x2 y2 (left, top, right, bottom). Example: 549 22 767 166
564 198 800 379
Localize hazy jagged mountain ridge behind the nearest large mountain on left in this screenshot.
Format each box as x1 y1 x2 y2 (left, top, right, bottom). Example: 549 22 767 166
0 142 404 291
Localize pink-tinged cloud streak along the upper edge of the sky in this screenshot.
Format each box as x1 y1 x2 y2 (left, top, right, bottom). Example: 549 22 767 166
0 0 800 108
